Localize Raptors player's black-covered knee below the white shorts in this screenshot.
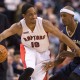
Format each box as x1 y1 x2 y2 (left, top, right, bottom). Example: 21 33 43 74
19 68 34 80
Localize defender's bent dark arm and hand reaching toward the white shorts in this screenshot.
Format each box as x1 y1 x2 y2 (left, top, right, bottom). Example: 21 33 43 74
44 43 76 71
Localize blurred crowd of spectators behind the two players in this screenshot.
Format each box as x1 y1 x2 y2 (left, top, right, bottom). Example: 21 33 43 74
0 0 80 80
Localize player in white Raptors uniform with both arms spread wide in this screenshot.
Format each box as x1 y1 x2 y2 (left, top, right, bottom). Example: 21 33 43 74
0 3 80 80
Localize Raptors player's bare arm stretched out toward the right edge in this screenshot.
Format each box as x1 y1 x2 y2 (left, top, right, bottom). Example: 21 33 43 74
43 20 80 55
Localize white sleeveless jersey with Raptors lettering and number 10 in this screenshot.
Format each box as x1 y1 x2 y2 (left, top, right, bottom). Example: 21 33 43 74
20 17 49 52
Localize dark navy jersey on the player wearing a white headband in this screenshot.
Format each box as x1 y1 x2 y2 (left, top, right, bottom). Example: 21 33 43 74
63 22 80 47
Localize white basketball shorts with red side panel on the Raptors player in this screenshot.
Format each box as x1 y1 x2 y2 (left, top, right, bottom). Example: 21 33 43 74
20 44 50 80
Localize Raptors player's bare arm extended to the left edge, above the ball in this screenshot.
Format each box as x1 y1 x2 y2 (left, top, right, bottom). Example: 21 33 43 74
0 23 21 41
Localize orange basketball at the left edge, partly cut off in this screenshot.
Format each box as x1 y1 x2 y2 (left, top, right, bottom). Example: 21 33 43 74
0 45 8 63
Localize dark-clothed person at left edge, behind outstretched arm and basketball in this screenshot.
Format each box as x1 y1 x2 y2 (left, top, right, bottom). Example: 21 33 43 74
0 13 10 80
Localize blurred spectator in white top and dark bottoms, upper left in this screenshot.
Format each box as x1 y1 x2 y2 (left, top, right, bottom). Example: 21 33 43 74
4 0 22 24
